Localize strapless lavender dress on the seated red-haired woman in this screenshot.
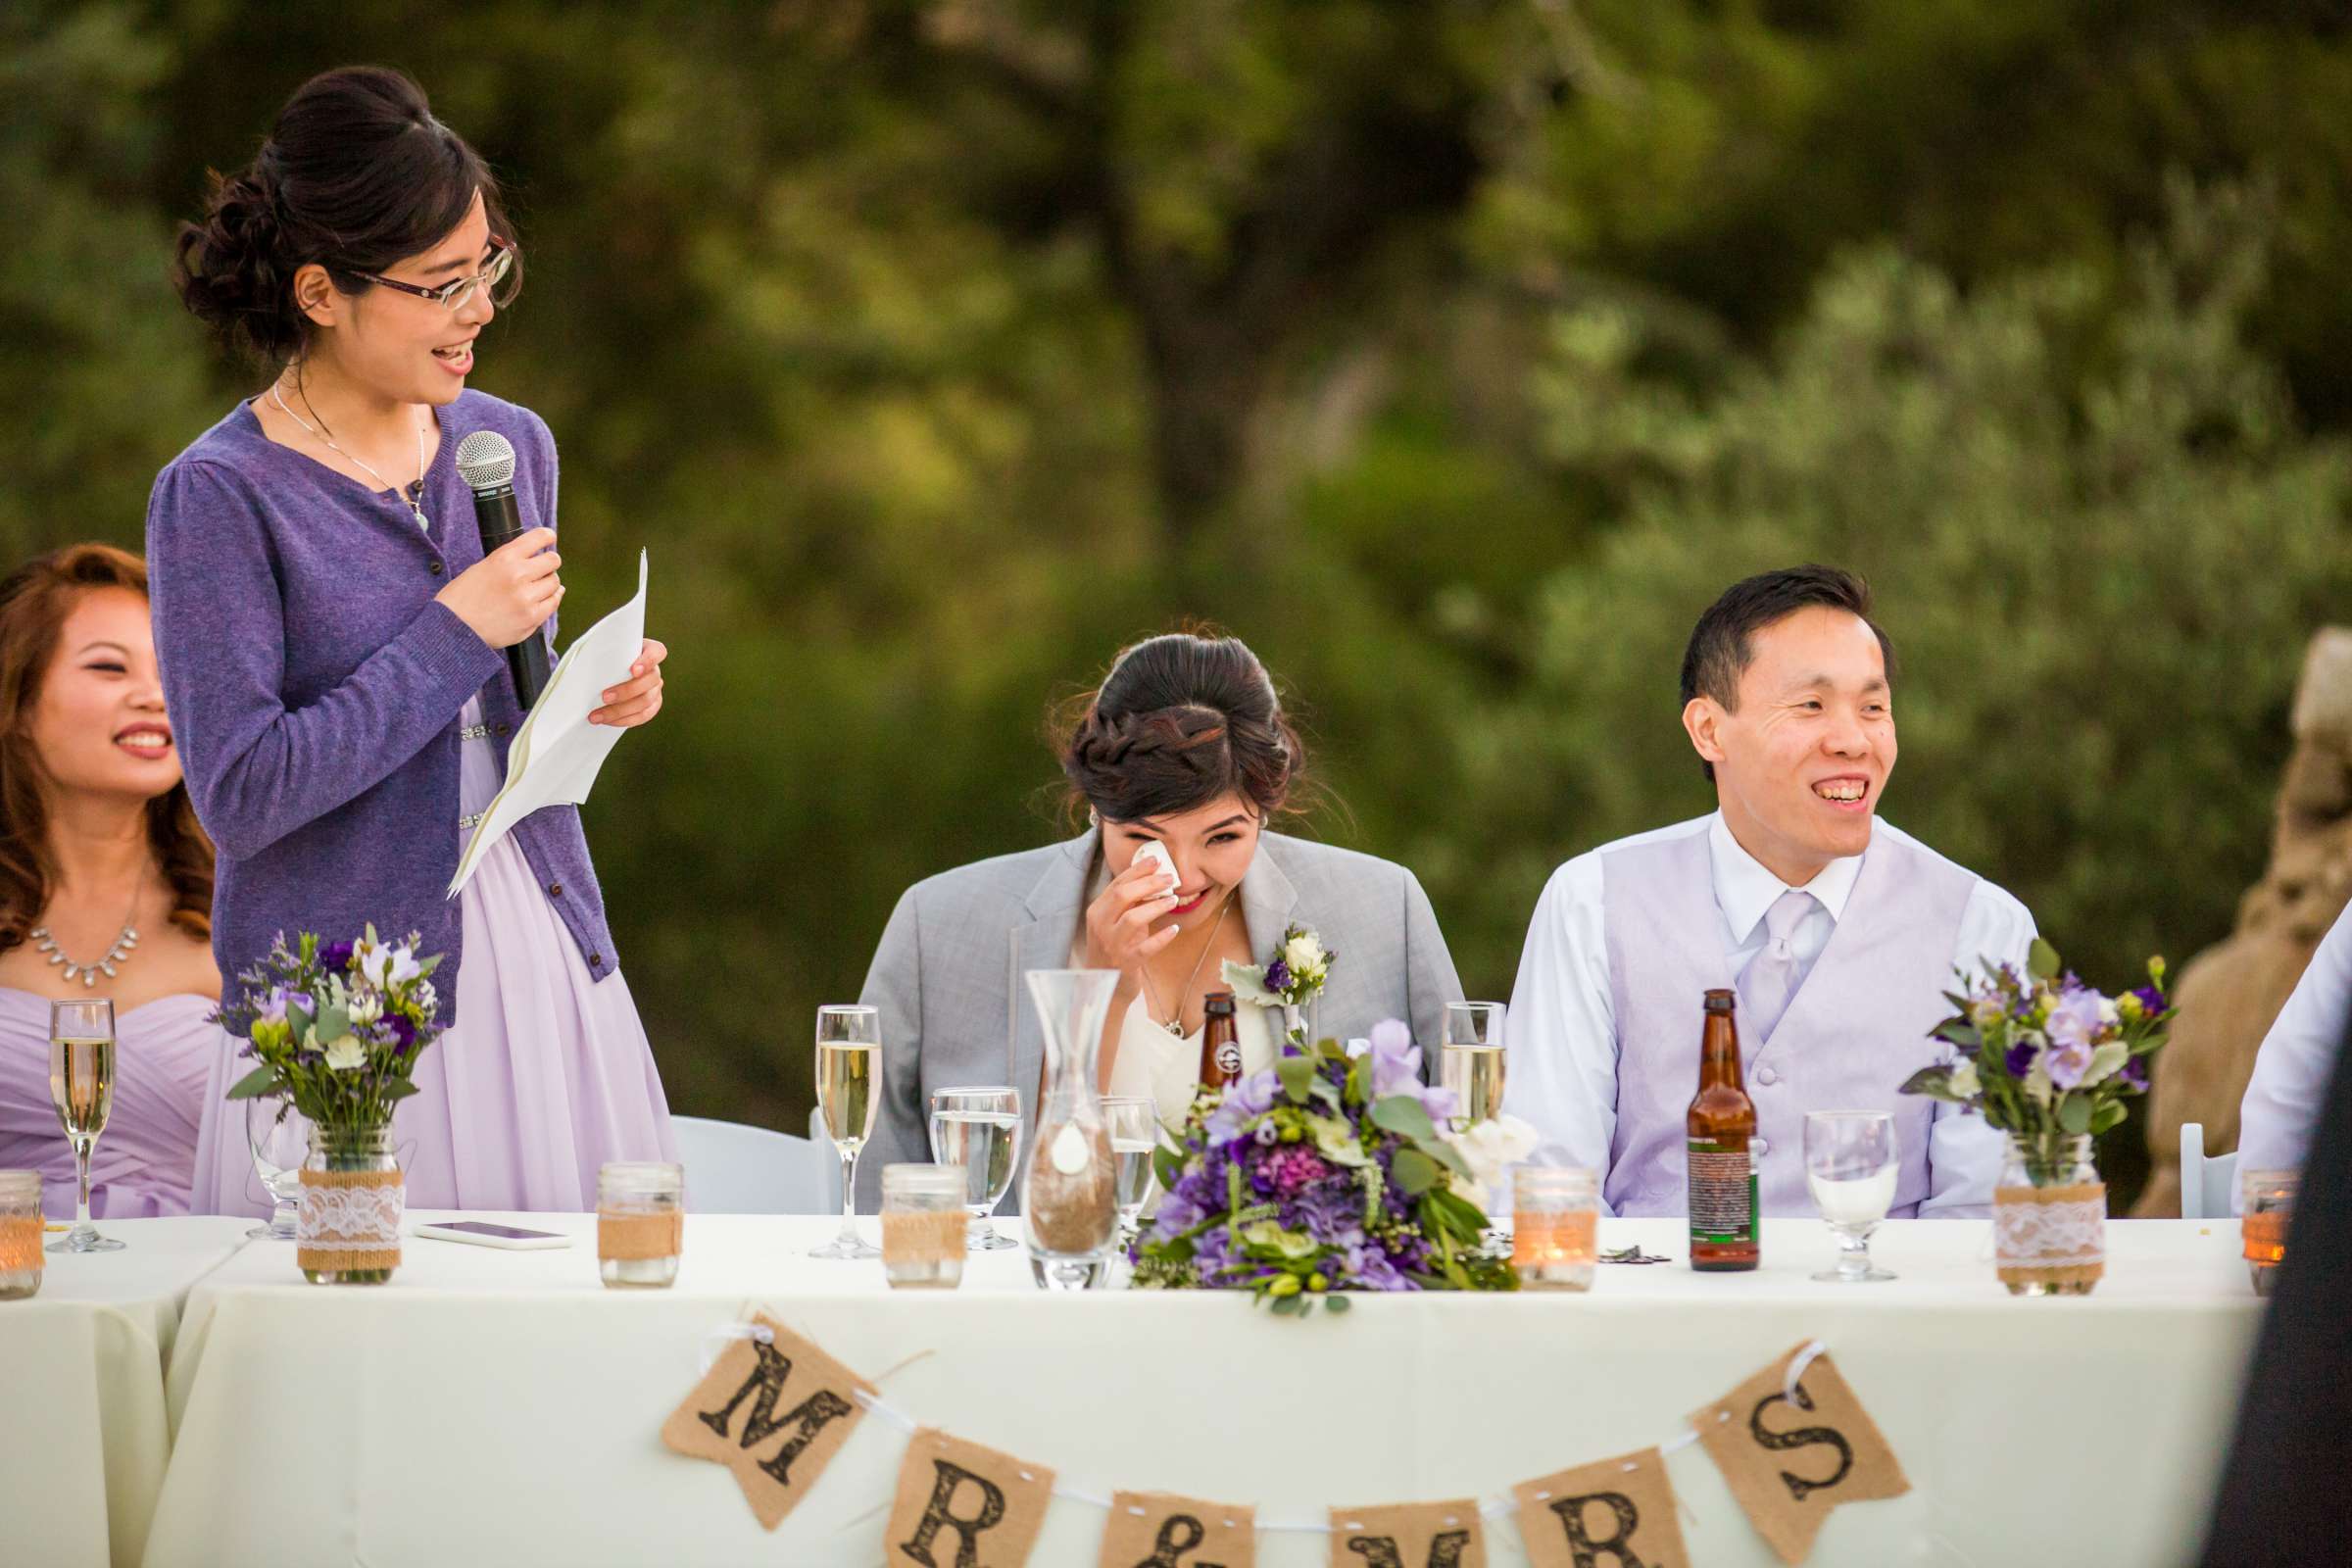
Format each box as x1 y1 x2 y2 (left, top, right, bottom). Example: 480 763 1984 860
0 987 221 1220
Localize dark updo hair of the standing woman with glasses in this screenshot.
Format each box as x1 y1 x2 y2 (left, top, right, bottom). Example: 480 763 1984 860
172 66 522 367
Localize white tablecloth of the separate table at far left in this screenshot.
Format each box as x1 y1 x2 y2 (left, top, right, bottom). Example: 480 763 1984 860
0 1218 252 1568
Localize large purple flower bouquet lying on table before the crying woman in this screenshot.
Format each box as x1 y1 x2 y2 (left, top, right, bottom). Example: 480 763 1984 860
1129 1020 1519 1314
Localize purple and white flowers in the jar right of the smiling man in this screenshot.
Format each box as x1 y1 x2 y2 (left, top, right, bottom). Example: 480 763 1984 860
1903 938 2174 1185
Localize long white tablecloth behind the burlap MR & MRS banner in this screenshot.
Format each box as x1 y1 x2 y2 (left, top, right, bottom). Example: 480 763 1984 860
148 1215 2260 1568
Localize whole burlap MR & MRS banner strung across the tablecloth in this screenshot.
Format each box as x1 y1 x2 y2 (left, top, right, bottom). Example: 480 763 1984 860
661 1314 1910 1568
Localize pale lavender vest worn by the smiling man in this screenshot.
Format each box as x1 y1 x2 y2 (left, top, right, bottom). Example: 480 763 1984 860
1601 825 1976 1218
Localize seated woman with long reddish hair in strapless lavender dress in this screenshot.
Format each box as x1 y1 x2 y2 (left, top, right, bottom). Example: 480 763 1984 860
0 546 221 1220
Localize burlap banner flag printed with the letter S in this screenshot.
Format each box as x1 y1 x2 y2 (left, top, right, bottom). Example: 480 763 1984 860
1691 1345 1910 1563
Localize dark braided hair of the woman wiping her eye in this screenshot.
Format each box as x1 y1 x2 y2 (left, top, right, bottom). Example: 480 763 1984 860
1058 632 1305 823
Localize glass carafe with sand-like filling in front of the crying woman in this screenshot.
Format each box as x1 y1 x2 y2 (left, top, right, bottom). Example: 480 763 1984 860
1021 968 1119 1291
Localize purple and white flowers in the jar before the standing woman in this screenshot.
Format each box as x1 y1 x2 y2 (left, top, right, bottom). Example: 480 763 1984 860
214 926 442 1131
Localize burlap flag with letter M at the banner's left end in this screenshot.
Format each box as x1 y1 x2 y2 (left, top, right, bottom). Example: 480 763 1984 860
661 1314 872 1531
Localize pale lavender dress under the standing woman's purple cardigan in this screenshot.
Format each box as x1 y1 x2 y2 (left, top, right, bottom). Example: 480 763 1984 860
189 703 677 1215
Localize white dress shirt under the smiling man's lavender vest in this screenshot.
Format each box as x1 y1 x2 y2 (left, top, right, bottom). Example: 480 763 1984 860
1505 811 2034 1218
